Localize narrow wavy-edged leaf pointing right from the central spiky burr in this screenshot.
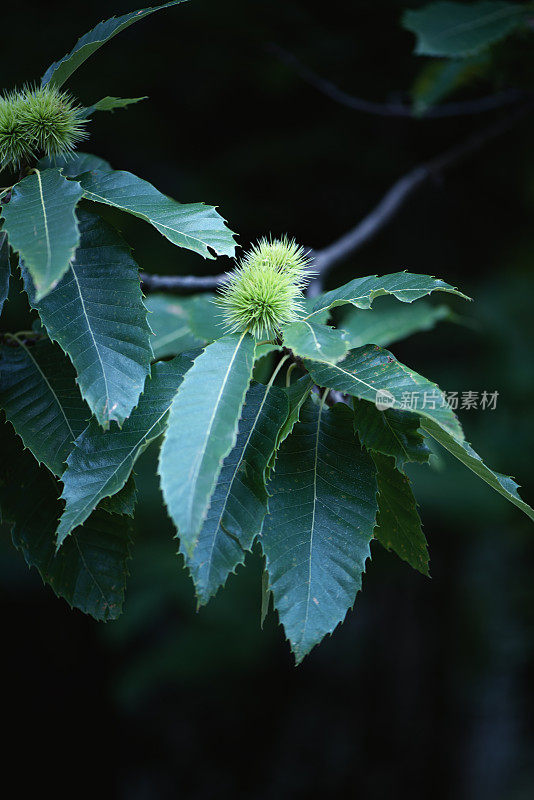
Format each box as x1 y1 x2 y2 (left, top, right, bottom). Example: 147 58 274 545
306 272 469 319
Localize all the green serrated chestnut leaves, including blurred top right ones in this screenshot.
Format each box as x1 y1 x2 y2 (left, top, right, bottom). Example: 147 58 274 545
0 0 534 662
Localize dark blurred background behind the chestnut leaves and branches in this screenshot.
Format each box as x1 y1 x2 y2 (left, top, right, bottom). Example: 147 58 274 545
0 0 534 800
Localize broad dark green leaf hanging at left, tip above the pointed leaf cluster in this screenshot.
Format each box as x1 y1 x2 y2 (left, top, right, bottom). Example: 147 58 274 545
23 210 152 427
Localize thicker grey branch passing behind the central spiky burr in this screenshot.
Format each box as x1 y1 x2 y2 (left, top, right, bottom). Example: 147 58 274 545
141 101 534 297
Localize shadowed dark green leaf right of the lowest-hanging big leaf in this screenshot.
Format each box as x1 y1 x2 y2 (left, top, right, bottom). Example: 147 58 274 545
373 453 429 575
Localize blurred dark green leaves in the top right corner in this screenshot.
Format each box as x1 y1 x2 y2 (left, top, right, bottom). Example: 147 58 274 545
403 0 534 116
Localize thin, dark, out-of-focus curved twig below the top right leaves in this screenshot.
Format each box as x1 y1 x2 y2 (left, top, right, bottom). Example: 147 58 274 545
267 43 528 119
